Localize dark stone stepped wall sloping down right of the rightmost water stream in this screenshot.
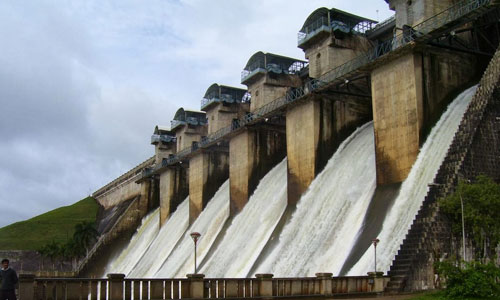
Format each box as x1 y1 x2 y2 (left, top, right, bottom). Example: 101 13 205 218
386 48 500 293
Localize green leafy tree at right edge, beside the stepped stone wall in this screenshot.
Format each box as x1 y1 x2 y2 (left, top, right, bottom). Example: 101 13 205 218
440 175 500 260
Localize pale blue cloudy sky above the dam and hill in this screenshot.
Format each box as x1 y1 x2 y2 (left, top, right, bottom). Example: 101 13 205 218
0 0 392 227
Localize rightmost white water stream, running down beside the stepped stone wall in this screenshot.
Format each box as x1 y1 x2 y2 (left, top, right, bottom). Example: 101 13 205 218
348 86 477 275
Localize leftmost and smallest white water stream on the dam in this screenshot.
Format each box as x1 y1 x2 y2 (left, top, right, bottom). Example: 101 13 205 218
104 209 160 274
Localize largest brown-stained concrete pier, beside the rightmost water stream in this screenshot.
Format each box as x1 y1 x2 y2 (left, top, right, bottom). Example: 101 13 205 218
372 48 478 185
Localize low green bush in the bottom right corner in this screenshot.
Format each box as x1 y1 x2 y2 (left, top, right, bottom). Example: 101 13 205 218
437 261 500 299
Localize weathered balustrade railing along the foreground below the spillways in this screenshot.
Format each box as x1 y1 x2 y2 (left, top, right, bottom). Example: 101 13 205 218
19 273 389 300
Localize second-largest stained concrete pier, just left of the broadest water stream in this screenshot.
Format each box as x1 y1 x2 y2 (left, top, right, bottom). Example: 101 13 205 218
286 96 371 204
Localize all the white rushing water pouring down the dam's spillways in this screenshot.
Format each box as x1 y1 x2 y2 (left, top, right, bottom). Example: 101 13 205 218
107 88 475 277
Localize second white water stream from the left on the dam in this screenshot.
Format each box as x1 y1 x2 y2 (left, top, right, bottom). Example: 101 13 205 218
127 197 189 278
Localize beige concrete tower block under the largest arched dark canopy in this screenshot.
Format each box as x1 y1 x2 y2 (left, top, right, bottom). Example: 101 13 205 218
304 35 371 78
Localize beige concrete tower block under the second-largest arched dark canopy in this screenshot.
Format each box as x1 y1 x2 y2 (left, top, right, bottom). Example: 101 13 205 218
248 72 301 112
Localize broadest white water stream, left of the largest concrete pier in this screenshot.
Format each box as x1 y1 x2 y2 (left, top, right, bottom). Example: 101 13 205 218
256 123 376 277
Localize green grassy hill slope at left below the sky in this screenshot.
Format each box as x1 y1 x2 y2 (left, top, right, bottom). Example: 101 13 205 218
0 197 99 250
